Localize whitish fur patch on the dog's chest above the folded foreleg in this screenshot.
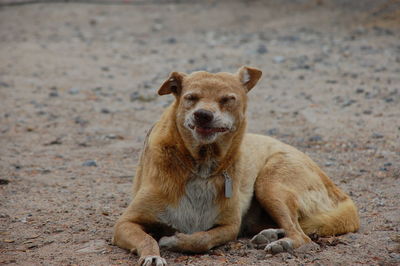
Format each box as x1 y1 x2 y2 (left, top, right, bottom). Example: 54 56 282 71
158 177 219 234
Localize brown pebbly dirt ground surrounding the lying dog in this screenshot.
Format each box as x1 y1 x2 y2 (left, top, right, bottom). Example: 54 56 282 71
0 0 400 265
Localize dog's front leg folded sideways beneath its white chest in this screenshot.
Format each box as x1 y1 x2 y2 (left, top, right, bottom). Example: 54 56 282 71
159 223 239 253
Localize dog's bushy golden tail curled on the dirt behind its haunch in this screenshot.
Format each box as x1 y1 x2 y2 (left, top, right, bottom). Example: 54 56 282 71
299 198 360 236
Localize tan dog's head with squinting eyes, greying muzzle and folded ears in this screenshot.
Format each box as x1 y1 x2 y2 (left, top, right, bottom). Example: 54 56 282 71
158 66 262 144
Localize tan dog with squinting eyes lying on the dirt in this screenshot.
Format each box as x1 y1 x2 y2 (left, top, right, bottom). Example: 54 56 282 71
113 67 359 265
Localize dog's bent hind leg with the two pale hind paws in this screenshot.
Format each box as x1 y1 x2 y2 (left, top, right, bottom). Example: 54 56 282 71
252 155 312 253
